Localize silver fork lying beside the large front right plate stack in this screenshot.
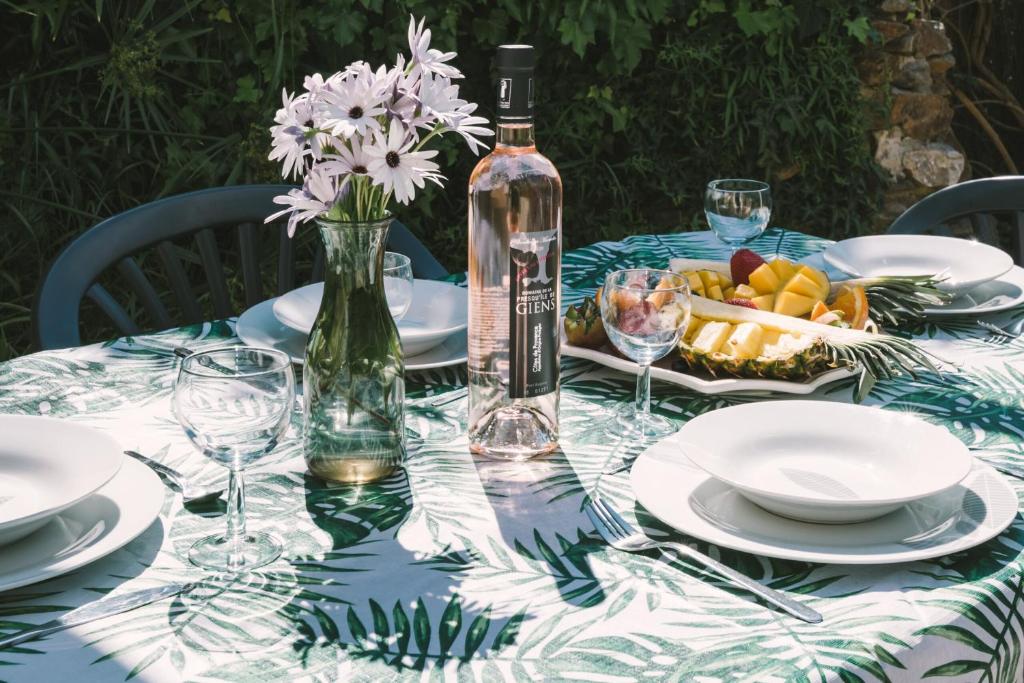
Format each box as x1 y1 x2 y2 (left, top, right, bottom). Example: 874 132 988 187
587 498 821 624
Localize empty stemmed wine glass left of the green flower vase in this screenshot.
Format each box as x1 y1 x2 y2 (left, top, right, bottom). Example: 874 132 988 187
172 346 295 571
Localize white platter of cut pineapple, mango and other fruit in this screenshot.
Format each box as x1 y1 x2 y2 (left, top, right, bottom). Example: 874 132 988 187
563 249 947 400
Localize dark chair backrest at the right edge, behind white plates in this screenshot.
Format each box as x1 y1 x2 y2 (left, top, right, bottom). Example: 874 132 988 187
889 175 1024 264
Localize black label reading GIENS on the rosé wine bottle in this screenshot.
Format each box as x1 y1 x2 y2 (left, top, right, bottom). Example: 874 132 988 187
509 230 561 398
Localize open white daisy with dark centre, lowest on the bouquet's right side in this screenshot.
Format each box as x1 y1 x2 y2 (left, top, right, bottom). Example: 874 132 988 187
365 119 444 204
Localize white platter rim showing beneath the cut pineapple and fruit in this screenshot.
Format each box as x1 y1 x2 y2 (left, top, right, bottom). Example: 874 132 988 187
562 328 857 394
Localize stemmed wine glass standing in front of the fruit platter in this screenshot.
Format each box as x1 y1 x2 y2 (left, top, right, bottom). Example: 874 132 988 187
600 268 690 440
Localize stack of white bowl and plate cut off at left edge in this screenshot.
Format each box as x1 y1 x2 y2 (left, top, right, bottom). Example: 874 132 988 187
0 415 165 591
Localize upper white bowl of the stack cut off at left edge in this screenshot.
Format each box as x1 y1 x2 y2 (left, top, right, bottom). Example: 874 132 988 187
0 415 124 546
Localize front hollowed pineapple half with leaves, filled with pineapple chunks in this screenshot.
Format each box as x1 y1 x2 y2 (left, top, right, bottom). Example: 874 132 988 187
679 297 938 401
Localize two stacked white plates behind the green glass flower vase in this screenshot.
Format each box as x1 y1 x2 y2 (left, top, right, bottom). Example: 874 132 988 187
236 280 469 370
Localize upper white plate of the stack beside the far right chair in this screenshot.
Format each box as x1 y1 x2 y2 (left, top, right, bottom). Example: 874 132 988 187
823 234 1014 294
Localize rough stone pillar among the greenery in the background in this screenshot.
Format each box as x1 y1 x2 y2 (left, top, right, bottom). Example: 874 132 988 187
859 0 966 231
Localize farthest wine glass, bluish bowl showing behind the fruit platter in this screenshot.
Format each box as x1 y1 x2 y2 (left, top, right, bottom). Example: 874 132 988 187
705 178 771 253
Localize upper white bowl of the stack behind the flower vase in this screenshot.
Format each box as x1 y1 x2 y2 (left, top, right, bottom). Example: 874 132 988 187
273 280 469 356
